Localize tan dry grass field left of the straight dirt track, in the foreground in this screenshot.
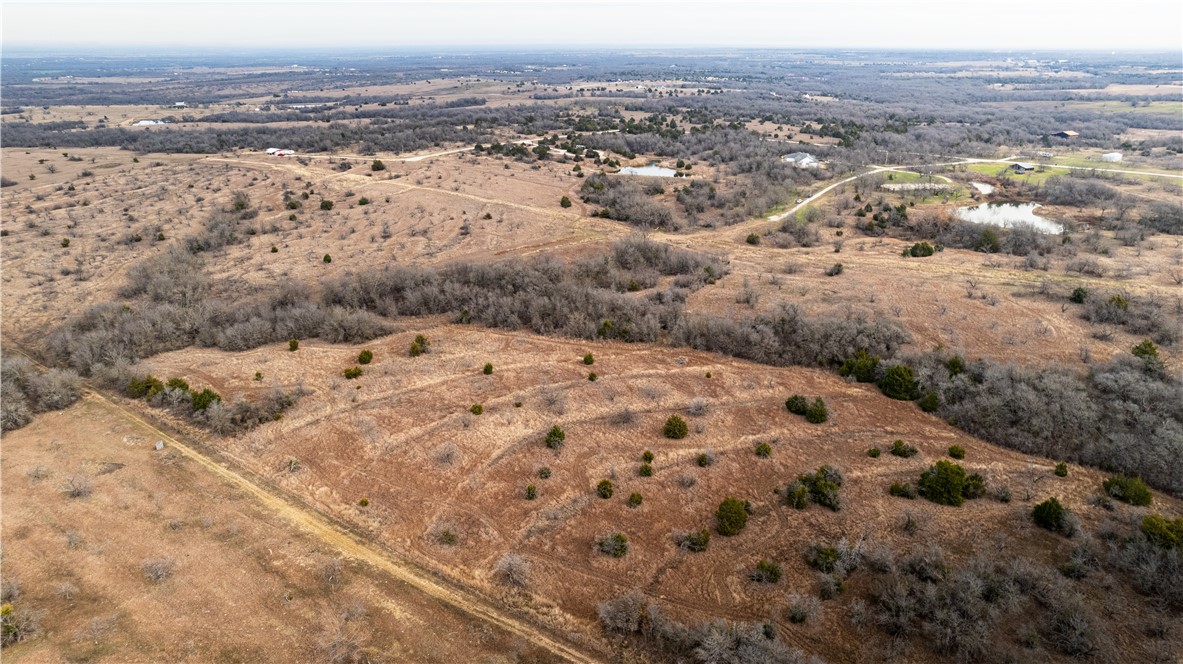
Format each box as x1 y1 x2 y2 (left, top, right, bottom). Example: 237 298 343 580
0 390 548 664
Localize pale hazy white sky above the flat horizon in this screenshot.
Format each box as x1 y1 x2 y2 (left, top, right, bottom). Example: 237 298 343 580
0 0 1183 52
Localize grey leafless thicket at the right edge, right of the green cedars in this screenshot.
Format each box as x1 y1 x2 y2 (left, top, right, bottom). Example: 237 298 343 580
906 353 1183 495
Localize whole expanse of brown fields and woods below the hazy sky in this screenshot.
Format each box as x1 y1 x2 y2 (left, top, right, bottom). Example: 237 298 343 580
0 51 1183 664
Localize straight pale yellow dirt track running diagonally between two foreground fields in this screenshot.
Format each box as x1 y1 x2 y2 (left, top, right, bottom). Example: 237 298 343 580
6 344 602 663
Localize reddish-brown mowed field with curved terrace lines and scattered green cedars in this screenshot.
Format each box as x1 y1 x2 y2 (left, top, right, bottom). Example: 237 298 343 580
124 320 1183 662
